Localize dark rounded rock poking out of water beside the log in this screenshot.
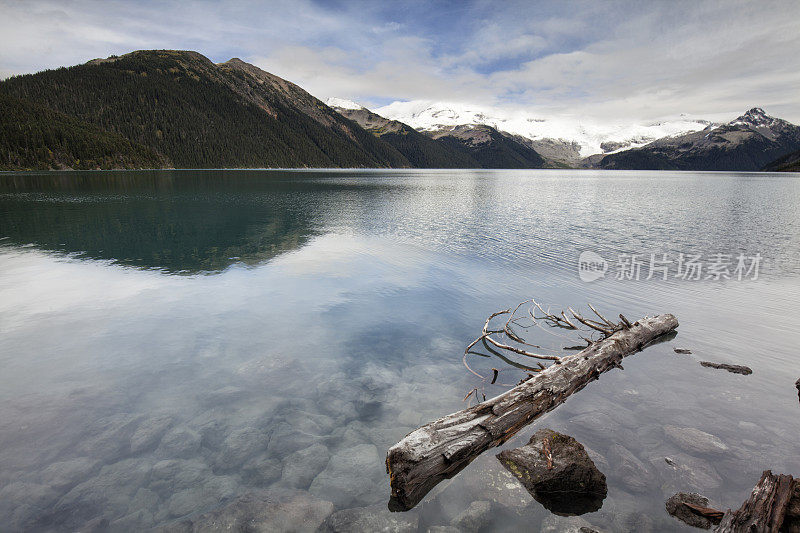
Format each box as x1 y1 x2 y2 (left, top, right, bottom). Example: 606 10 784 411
497 429 608 515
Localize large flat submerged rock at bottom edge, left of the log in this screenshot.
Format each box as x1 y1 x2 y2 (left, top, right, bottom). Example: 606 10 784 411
159 490 333 533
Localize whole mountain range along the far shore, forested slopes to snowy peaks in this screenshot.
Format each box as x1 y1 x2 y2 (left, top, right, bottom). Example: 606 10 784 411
0 50 800 171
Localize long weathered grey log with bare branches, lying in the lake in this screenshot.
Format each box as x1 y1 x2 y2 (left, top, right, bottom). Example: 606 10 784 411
386 314 678 511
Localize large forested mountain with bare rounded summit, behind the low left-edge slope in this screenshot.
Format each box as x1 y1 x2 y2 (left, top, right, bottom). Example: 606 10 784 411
0 50 410 168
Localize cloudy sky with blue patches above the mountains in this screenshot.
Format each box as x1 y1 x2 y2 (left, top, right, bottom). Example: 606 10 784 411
0 0 800 123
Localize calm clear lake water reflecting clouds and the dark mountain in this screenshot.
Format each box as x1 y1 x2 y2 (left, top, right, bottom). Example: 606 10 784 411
0 170 800 532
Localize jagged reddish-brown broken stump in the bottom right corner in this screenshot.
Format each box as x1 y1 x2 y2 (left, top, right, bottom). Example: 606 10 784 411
714 470 800 533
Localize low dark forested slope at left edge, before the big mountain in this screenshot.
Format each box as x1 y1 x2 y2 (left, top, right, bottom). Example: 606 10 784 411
0 94 170 170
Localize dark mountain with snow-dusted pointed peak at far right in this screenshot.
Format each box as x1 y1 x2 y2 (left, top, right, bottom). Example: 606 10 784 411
597 107 800 171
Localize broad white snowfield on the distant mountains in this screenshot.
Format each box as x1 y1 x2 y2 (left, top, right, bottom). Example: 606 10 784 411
370 100 711 158
